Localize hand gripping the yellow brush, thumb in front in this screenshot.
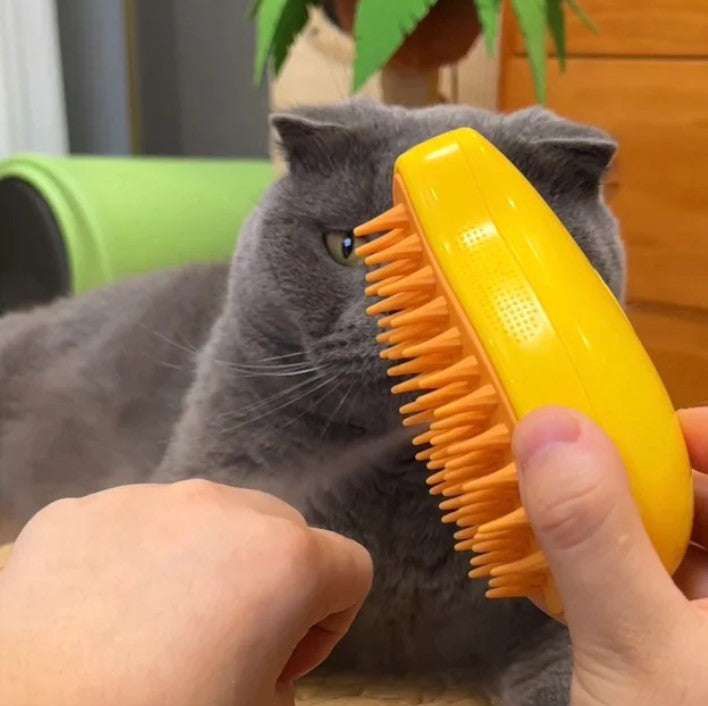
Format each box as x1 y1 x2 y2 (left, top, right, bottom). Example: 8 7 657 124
514 408 708 706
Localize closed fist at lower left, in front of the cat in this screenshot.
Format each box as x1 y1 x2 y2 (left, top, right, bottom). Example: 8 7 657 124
0 480 372 706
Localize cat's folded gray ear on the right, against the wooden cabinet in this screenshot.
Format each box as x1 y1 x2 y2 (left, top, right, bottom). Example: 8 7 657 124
509 106 617 189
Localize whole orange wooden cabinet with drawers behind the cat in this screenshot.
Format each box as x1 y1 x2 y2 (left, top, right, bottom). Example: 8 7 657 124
499 0 708 405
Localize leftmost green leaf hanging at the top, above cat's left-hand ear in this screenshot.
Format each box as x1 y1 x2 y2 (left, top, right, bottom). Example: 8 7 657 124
255 0 308 82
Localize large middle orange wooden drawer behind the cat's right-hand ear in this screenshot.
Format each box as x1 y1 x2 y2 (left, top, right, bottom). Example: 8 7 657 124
500 57 708 309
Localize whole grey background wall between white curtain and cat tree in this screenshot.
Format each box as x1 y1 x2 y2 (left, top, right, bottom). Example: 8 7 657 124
54 0 268 157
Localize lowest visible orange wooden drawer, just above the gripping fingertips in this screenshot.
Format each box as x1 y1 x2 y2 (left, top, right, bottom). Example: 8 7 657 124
627 305 708 407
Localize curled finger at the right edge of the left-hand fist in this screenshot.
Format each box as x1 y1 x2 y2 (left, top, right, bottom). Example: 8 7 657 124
281 529 373 680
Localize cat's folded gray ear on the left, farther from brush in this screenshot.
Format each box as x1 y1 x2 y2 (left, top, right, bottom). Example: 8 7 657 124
270 113 351 172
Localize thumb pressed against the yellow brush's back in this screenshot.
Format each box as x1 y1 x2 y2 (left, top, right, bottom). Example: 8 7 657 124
514 408 680 654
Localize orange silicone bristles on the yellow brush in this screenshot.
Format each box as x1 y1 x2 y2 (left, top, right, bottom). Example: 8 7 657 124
354 197 549 598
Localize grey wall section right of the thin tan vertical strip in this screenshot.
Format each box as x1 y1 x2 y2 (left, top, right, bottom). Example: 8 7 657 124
127 0 268 157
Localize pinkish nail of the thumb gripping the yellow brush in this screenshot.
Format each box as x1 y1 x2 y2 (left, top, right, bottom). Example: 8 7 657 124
512 407 581 472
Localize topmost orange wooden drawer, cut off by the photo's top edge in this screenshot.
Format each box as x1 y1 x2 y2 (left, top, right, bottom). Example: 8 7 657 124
506 0 708 57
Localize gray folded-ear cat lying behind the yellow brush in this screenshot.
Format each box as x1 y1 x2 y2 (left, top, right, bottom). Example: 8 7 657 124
0 100 624 706
